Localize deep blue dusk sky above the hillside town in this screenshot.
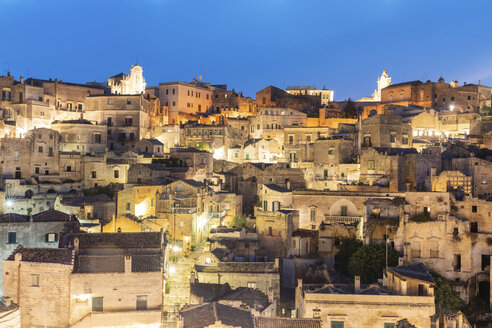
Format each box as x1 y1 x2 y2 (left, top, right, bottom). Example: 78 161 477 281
0 0 492 100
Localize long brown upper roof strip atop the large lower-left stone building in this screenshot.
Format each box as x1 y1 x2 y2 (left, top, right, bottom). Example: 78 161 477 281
62 232 161 249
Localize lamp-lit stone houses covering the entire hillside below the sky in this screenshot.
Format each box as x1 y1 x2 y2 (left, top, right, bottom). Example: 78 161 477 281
0 64 492 328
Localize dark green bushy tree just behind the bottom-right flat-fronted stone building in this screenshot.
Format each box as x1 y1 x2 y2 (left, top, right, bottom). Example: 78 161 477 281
348 245 399 284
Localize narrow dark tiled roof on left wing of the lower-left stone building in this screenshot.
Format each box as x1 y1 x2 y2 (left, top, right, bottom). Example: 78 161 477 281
7 245 73 265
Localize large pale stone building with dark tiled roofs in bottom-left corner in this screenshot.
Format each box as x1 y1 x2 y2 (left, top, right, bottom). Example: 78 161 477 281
3 232 166 327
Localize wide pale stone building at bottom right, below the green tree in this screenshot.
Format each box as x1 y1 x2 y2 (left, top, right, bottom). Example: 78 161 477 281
296 266 435 328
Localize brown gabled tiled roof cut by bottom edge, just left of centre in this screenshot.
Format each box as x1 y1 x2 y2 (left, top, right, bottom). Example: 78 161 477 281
180 302 254 328
